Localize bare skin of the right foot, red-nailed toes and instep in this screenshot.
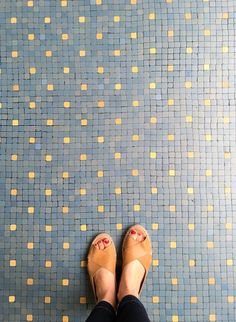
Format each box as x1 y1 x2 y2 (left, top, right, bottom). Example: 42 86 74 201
117 228 146 302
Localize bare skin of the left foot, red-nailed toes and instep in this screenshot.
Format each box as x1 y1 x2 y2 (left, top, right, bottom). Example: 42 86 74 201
94 238 116 308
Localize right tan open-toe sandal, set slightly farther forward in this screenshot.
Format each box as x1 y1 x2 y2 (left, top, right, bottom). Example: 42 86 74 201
122 225 152 294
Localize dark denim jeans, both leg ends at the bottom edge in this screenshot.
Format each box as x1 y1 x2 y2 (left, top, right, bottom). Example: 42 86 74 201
86 295 150 322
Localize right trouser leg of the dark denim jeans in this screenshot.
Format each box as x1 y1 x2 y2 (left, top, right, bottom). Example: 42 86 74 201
117 295 150 322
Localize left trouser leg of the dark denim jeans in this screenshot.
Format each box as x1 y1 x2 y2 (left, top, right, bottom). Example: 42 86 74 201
86 301 116 322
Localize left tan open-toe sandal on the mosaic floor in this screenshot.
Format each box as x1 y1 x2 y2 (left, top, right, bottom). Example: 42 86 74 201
88 233 116 303
